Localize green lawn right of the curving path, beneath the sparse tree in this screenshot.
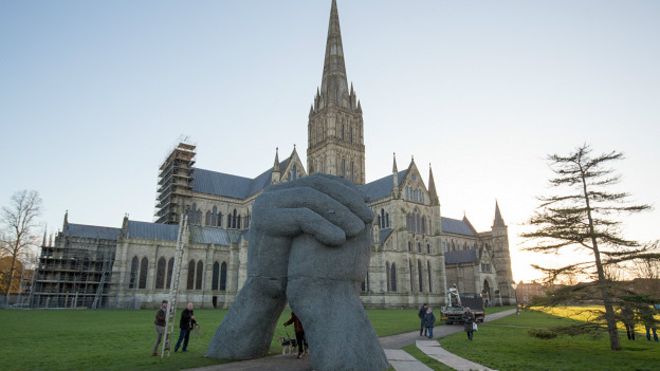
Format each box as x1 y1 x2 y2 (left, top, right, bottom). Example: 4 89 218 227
440 311 660 370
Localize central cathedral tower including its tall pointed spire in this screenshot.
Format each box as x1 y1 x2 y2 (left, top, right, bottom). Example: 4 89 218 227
307 0 365 184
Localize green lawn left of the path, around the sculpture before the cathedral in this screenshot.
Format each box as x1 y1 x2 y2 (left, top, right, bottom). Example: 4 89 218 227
0 309 419 370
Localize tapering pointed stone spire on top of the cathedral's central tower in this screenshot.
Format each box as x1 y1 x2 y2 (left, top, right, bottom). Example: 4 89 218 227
321 0 349 108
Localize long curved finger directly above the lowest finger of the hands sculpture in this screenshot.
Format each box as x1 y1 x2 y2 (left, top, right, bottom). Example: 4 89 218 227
253 186 365 237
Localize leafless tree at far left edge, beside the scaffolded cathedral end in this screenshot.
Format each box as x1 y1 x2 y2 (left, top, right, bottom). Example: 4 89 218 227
0 190 42 303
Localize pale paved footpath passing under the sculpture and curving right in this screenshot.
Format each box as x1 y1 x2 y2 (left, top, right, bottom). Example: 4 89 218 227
188 309 516 371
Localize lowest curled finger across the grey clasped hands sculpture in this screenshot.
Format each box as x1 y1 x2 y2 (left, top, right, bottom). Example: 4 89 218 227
255 207 346 246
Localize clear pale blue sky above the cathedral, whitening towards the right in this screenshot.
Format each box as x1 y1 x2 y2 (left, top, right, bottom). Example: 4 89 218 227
0 0 660 280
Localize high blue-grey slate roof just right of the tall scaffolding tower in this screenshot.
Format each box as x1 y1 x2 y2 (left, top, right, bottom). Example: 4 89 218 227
187 158 289 200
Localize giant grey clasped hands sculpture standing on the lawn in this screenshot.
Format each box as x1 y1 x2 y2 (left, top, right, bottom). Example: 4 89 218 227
207 174 388 371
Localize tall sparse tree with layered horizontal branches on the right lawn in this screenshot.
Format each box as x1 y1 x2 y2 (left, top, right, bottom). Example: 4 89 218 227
522 144 650 350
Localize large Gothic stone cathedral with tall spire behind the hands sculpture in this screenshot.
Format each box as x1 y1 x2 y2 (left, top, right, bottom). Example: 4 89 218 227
30 0 515 308
